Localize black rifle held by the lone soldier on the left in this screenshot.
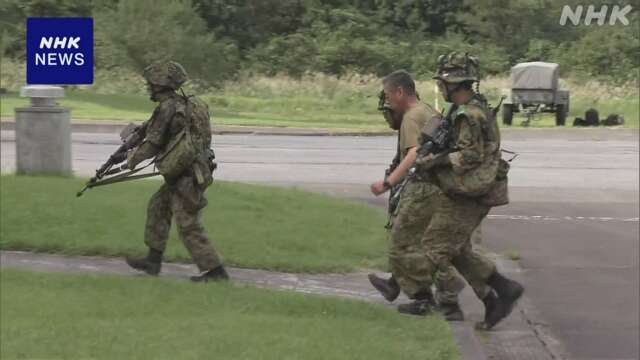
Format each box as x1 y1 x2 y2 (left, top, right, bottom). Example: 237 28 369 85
76 121 157 197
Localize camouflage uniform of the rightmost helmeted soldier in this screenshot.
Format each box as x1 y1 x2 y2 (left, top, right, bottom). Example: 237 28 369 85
399 95 499 298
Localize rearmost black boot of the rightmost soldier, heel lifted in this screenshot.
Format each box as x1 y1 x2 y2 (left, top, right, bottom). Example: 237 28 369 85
480 272 524 330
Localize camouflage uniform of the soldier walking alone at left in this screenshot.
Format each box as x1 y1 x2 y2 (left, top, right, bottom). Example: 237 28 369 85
128 63 222 272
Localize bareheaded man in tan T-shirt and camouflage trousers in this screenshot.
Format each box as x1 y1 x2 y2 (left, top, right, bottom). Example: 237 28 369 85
369 70 465 321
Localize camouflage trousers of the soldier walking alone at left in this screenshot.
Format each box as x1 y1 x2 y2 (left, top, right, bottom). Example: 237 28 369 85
144 176 222 271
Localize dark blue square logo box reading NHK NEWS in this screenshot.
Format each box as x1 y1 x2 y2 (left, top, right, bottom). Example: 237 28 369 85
27 17 93 85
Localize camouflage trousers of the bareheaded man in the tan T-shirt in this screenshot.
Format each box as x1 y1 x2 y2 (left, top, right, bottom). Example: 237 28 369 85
389 180 465 304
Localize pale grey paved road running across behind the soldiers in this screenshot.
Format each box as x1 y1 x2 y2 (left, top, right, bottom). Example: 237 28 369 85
1 130 638 202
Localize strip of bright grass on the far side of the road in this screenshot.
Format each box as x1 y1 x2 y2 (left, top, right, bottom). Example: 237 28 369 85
5 91 640 130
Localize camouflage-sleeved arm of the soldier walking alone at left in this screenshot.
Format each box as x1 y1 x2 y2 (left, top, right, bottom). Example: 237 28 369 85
127 102 175 169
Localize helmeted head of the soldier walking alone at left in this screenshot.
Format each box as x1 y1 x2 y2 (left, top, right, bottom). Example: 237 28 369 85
142 61 187 101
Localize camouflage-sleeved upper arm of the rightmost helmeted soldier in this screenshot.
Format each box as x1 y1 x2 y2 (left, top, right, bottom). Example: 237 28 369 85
449 113 484 174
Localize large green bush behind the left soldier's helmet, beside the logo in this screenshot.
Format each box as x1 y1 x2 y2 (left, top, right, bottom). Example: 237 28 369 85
95 0 238 83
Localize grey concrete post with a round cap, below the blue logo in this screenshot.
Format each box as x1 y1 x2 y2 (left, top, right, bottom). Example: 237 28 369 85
15 85 72 176
